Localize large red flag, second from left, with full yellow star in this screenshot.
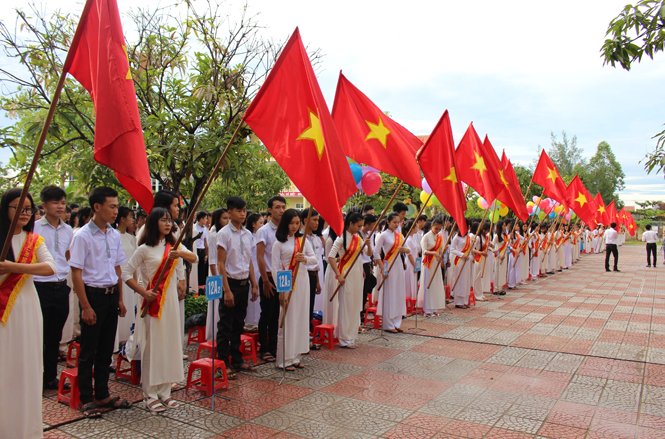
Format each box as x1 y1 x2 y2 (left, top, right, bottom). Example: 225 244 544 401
244 28 357 235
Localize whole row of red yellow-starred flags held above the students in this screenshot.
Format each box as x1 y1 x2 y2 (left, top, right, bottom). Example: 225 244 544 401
58 0 634 234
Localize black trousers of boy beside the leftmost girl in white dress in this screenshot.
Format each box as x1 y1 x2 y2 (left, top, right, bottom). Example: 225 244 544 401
35 282 71 383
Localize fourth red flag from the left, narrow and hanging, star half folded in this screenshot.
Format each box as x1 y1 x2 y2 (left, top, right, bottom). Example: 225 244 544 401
416 110 467 239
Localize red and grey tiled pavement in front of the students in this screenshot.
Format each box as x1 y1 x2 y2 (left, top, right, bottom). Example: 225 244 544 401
43 246 665 439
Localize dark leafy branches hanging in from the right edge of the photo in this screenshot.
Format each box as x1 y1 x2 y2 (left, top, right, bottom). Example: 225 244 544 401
601 0 665 174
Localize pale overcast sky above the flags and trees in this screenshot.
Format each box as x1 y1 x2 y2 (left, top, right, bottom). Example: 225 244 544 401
0 0 665 205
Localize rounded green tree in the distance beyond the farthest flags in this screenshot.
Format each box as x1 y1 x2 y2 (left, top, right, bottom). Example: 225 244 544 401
580 141 626 210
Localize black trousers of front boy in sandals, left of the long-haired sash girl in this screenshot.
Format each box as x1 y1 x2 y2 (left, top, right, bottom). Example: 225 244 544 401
79 287 120 404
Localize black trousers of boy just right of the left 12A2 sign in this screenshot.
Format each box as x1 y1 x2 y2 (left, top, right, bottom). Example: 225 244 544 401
217 278 250 367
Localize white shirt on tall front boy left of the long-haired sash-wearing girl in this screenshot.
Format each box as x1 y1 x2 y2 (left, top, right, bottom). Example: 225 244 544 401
69 221 127 288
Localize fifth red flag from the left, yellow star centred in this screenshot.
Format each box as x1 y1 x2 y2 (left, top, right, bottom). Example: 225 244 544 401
456 122 505 203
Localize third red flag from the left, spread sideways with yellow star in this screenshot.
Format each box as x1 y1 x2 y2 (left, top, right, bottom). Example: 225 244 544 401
332 72 423 188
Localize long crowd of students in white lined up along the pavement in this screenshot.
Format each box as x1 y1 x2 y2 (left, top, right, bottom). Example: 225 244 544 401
0 186 632 438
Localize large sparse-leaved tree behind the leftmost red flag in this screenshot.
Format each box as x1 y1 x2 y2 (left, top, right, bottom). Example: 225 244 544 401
0 1 280 211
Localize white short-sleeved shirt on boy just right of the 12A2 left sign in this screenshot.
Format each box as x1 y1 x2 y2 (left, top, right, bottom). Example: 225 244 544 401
217 222 254 280
